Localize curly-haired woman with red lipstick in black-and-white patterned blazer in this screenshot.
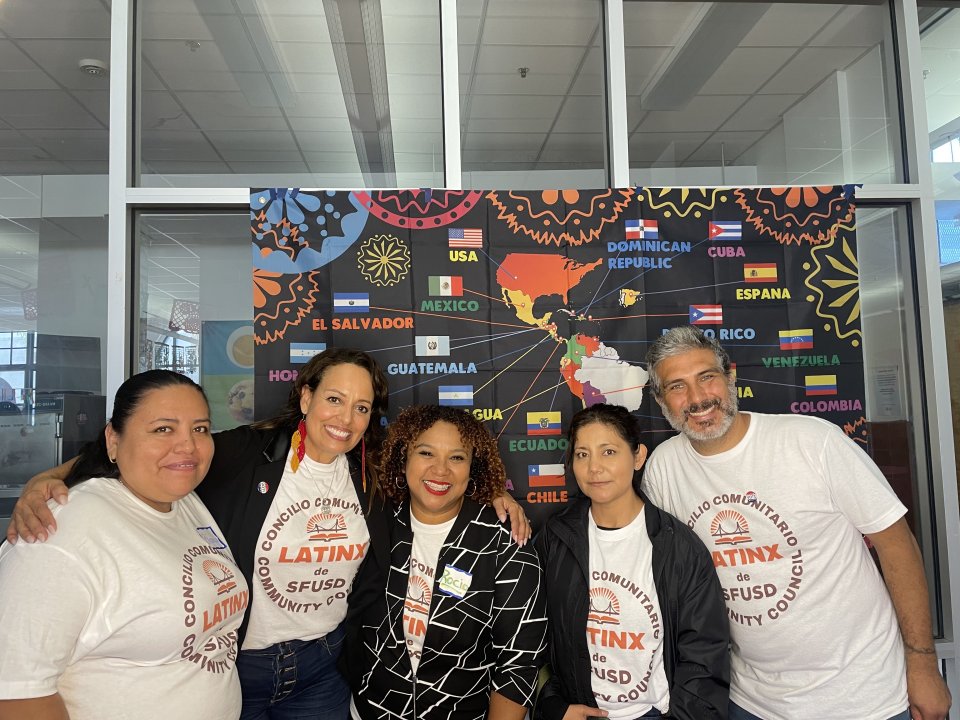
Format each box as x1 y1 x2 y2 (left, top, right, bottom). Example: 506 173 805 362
343 405 546 720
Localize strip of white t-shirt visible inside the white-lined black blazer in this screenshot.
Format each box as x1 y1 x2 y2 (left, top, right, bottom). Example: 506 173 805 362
403 513 457 673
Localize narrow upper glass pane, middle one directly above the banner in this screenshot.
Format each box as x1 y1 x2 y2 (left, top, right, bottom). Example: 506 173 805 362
457 0 607 189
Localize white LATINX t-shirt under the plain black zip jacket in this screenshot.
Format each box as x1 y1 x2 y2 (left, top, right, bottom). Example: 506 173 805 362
587 511 670 718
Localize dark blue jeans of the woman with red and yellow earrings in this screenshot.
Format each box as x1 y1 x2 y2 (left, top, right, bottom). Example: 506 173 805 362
237 625 350 720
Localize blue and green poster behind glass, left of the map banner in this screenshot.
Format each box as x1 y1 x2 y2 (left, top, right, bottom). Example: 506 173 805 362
200 320 254 430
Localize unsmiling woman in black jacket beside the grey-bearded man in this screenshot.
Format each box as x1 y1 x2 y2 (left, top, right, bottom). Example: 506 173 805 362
536 404 730 720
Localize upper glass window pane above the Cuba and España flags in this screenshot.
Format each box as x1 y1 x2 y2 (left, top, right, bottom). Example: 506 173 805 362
624 0 903 185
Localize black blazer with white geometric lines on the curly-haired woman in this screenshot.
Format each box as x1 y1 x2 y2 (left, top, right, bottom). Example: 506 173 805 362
344 499 547 720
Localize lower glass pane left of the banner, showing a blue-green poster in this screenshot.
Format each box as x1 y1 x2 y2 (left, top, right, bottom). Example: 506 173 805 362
137 213 253 430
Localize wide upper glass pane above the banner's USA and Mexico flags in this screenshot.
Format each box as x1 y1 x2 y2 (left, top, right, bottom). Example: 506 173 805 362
137 0 443 187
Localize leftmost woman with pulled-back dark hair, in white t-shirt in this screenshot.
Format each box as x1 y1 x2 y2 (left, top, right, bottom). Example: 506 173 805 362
0 370 248 720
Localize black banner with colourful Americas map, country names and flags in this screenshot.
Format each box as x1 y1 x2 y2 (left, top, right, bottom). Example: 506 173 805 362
250 186 869 522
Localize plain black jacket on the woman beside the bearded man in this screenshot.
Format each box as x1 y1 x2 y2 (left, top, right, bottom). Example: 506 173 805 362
535 495 730 720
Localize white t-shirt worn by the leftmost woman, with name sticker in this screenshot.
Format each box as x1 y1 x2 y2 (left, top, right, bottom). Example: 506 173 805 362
0 478 248 720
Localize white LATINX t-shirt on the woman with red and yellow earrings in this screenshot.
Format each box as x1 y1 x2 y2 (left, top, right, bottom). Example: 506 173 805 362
243 450 370 650
